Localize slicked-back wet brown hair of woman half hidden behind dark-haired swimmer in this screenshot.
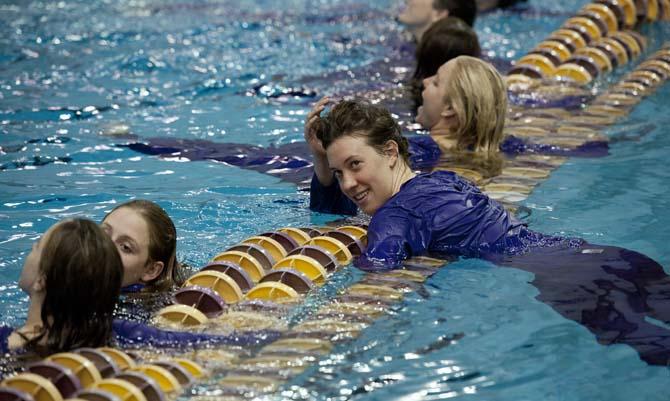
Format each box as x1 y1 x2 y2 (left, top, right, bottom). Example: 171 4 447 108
105 199 186 292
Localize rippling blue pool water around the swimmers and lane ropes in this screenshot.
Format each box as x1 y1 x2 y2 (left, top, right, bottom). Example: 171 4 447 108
0 0 670 401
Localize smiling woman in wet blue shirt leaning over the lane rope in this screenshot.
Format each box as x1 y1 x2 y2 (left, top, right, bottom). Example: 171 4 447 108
305 97 670 365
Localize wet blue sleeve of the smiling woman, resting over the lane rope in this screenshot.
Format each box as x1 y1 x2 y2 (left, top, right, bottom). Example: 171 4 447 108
355 206 431 271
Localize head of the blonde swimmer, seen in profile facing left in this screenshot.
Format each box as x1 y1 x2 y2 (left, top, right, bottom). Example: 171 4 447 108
417 56 507 152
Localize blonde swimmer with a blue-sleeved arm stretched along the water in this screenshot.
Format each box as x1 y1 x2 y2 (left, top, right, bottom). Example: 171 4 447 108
410 56 608 166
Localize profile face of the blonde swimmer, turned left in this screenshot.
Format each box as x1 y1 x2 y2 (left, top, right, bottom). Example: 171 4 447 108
416 60 457 130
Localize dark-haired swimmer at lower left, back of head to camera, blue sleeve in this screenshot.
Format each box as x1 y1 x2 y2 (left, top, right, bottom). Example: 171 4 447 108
0 219 279 356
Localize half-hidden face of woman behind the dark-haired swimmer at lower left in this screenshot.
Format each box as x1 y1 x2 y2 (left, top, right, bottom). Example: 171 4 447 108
102 207 154 287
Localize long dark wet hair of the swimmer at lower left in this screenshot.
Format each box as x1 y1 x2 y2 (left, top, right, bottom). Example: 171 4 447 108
25 219 123 355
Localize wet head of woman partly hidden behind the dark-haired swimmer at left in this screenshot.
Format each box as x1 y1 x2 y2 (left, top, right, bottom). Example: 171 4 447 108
102 199 184 291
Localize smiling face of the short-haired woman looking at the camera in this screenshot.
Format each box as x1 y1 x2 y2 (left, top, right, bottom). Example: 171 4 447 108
326 136 398 215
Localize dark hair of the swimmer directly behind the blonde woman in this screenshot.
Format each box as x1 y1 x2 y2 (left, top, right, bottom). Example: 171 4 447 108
410 17 481 109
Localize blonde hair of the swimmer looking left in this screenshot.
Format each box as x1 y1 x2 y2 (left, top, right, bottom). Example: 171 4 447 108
445 56 507 153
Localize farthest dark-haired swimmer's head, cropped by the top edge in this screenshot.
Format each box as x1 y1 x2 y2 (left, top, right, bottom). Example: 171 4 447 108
398 0 477 42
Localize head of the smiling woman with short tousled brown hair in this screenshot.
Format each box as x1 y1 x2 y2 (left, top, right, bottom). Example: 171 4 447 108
315 100 412 215
